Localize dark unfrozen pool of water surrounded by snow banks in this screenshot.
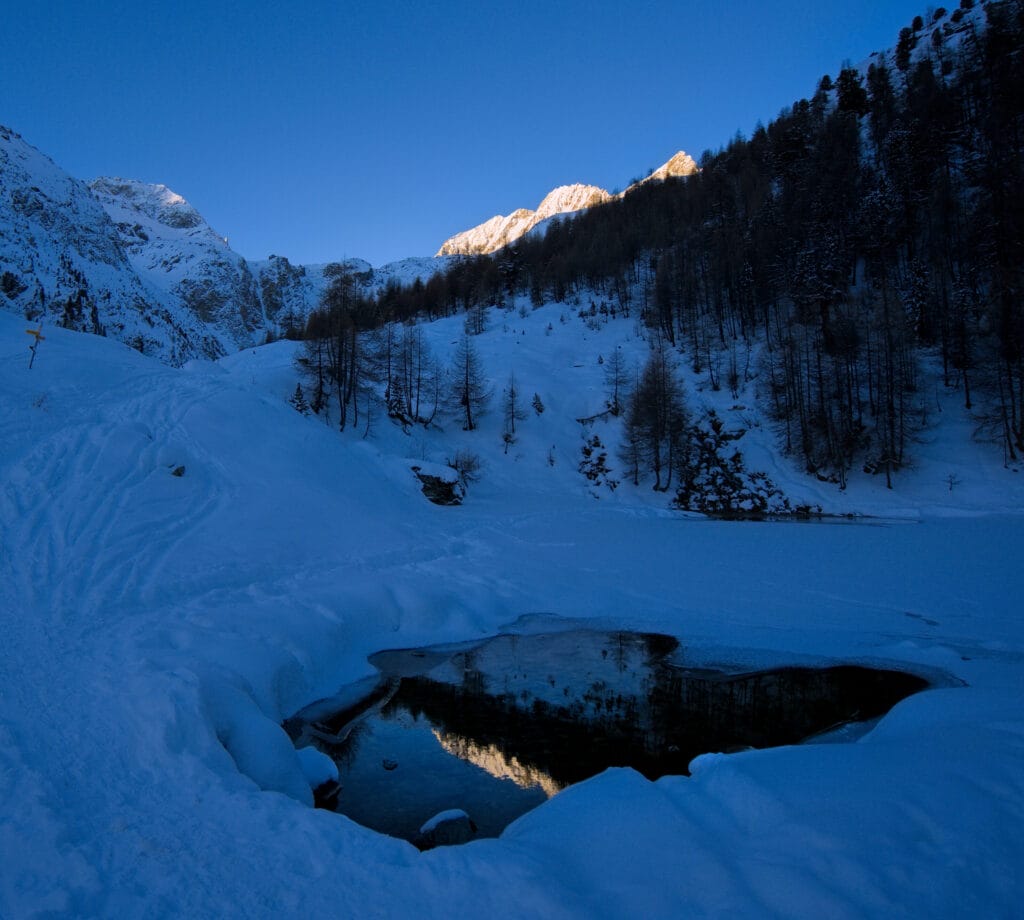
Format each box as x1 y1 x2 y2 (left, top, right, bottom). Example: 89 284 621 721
286 631 928 840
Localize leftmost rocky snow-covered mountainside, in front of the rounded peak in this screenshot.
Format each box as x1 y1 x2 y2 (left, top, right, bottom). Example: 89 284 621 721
0 127 224 363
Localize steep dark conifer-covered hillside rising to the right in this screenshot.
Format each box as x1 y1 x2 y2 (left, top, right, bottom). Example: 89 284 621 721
354 0 1024 485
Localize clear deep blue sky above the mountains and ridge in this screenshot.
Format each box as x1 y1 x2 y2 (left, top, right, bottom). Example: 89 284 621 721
0 0 929 264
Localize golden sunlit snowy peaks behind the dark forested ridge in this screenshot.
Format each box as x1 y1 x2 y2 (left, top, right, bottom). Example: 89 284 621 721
437 151 697 256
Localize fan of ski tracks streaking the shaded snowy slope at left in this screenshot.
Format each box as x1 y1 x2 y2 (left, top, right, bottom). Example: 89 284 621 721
3 368 218 628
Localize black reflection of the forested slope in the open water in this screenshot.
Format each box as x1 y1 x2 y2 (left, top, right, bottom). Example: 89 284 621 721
389 663 927 786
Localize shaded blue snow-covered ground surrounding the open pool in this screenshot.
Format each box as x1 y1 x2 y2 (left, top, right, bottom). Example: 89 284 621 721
0 306 1024 918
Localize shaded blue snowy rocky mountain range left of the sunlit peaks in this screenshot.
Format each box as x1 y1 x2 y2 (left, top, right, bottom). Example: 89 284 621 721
0 127 445 366
